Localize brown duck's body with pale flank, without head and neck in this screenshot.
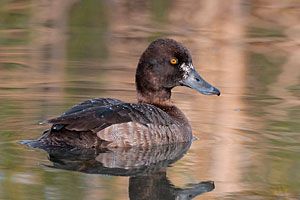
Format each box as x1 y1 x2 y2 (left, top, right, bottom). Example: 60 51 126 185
34 99 192 148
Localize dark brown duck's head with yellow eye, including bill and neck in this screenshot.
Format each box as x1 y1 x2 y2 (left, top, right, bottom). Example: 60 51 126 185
136 39 220 103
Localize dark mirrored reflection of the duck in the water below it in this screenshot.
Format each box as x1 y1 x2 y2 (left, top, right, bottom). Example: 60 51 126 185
46 143 215 200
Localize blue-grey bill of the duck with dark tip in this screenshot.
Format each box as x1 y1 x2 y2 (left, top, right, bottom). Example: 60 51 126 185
180 67 221 96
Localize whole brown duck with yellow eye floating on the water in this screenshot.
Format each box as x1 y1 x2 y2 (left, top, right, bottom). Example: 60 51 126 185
27 38 220 149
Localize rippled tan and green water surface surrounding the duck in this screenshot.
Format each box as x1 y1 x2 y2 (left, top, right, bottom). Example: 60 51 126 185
0 0 300 199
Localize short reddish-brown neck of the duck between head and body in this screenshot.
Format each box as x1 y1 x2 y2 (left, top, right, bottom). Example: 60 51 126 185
137 89 171 105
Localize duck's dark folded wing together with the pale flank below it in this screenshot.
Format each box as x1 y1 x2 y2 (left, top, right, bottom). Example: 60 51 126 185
48 99 180 147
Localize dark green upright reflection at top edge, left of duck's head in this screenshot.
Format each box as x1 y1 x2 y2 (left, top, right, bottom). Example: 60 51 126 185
67 0 108 60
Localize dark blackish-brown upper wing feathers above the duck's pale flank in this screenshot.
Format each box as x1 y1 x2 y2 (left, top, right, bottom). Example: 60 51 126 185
48 101 174 133
